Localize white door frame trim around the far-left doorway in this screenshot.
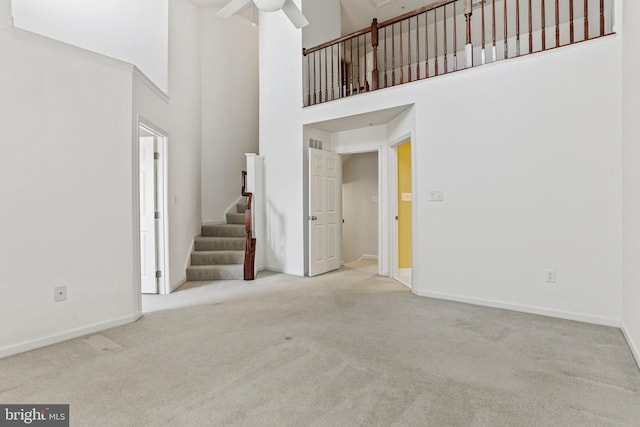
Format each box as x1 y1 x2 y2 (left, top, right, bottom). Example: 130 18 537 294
135 116 171 295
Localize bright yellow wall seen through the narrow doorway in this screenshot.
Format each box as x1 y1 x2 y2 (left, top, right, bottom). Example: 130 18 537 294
398 141 412 268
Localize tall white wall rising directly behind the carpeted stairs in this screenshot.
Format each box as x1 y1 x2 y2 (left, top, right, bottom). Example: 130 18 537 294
201 8 258 222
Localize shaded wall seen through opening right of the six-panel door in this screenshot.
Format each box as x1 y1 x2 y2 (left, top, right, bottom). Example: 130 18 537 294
342 152 379 262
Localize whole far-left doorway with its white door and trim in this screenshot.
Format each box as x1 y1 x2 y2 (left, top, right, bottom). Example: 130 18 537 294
138 121 169 294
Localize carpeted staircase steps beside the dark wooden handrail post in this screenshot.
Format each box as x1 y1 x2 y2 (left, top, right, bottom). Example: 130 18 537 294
187 203 247 282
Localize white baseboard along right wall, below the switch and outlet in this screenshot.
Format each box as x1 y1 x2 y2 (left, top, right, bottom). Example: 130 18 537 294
412 289 622 328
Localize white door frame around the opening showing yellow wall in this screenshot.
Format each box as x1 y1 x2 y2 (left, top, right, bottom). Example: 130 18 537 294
388 132 416 289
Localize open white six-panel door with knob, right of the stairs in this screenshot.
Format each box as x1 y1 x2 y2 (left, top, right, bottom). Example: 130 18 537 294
308 148 342 276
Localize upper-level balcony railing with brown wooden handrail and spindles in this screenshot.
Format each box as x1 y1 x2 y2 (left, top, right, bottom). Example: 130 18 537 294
303 0 613 106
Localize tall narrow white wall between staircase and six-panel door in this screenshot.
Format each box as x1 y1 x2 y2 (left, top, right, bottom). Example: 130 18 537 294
259 1 306 275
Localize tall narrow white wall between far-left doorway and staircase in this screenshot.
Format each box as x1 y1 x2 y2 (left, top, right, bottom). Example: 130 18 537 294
165 0 202 289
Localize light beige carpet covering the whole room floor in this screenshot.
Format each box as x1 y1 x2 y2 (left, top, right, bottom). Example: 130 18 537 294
0 265 640 426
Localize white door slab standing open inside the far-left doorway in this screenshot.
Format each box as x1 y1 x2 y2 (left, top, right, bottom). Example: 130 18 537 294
140 136 158 294
